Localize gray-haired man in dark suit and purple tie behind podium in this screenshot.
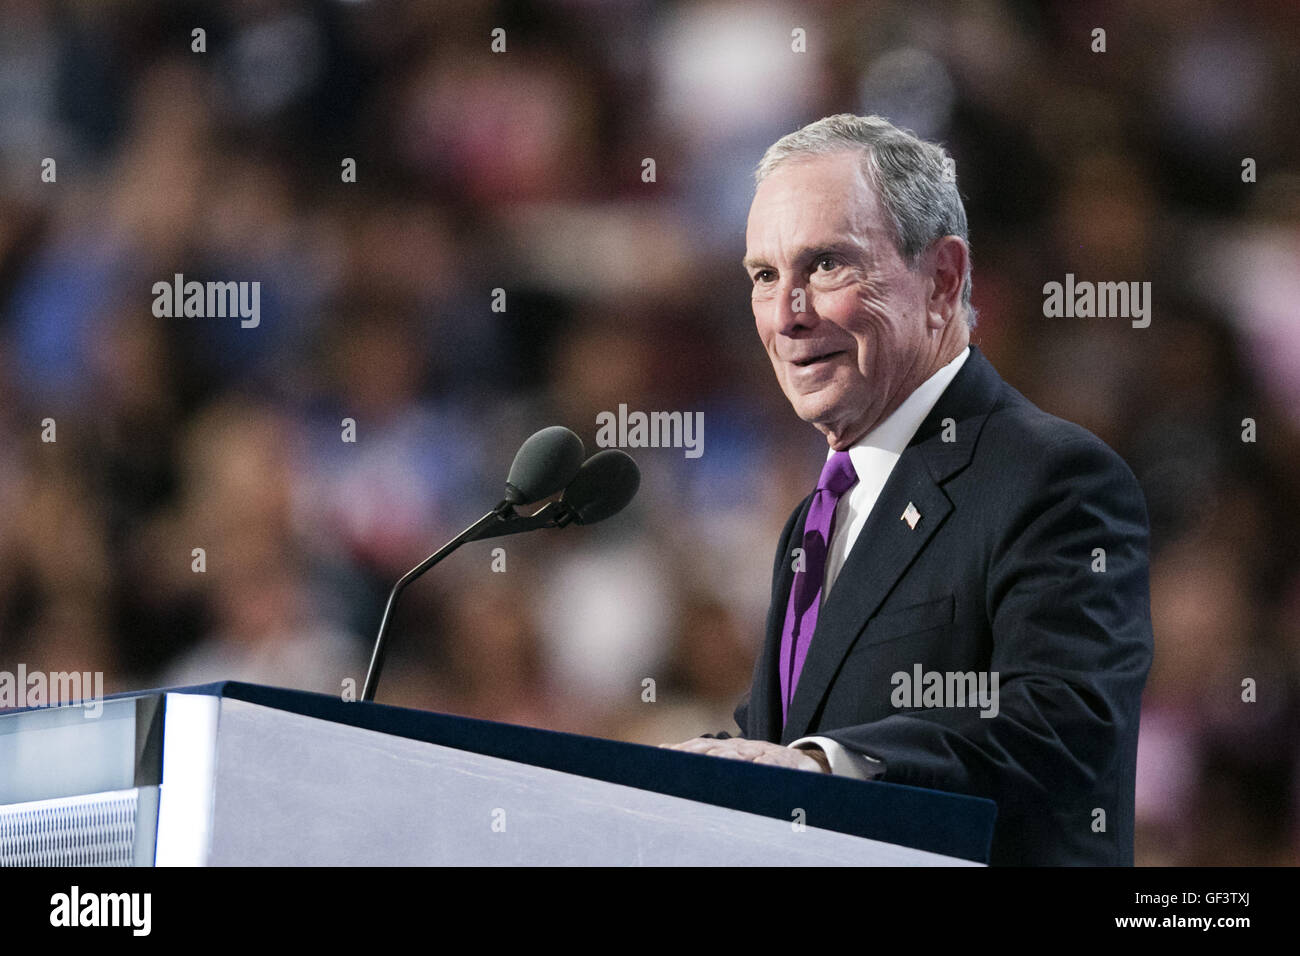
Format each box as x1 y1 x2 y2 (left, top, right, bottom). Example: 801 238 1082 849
677 116 1152 865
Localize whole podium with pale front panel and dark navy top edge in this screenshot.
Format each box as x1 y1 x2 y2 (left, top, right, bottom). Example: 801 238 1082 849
0 682 996 866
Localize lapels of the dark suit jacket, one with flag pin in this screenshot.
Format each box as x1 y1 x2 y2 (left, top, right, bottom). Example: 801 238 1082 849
764 345 1002 744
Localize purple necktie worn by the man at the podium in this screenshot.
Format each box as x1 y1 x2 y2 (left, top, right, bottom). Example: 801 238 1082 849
780 451 858 723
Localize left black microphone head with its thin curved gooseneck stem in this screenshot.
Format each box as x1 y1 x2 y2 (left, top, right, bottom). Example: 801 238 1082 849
361 425 586 701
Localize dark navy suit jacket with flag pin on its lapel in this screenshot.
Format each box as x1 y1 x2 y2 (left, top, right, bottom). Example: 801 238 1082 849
736 345 1152 865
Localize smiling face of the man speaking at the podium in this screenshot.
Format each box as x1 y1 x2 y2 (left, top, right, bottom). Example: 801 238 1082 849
745 151 939 449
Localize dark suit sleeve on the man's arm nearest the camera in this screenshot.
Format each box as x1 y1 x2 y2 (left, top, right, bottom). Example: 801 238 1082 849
818 436 1152 810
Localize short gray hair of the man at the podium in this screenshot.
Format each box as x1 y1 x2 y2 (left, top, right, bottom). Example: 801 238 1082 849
754 113 975 329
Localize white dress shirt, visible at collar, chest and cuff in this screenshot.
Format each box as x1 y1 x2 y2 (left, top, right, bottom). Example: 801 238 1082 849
790 346 971 780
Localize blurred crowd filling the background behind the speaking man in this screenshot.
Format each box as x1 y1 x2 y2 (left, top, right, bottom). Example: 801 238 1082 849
0 0 1300 864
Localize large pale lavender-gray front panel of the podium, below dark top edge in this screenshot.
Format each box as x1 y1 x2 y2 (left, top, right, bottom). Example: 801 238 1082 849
200 698 975 866
